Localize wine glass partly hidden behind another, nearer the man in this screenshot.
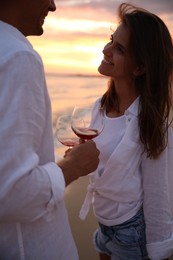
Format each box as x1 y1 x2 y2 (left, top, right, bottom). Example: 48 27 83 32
55 115 79 148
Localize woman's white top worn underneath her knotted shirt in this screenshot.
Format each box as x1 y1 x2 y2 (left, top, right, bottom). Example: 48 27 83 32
90 109 142 226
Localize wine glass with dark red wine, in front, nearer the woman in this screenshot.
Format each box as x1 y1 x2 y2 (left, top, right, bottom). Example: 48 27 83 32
71 106 104 141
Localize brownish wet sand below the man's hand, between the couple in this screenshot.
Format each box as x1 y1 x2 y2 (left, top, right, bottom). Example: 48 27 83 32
65 177 99 260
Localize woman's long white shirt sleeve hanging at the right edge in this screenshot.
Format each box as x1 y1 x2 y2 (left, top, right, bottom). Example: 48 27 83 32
142 128 173 260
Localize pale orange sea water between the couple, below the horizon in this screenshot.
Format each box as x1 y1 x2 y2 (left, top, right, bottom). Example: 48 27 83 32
46 73 108 158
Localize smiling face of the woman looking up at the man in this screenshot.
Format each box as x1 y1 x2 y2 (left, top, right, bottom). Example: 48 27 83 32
98 24 137 81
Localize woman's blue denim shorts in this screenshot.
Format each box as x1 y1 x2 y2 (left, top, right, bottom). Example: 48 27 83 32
94 209 149 260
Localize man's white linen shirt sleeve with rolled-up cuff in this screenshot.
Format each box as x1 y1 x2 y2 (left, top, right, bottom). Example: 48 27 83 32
0 52 65 222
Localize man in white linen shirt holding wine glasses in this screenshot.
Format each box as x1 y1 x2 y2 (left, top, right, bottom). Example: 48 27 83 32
0 0 99 260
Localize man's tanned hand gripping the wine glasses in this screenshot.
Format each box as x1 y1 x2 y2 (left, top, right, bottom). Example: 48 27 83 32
58 141 99 185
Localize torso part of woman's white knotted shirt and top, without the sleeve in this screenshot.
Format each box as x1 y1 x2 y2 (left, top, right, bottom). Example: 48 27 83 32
80 96 143 226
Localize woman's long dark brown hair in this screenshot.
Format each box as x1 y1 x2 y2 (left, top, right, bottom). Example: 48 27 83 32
101 3 173 159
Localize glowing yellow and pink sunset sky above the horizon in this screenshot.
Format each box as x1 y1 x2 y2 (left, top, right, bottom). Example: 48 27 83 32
29 0 173 74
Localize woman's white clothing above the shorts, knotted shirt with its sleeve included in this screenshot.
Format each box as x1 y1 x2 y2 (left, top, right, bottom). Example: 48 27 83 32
80 97 173 260
